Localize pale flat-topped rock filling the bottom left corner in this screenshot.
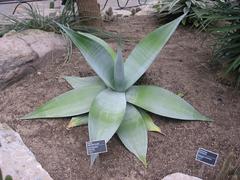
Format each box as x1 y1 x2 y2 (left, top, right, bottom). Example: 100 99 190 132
0 124 52 180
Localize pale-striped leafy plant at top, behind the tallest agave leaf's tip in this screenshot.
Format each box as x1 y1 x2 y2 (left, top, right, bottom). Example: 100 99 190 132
154 0 212 27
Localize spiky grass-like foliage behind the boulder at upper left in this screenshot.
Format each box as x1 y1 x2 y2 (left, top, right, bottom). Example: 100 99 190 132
0 0 115 38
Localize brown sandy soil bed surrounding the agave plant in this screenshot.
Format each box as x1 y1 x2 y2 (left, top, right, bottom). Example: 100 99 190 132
0 17 240 180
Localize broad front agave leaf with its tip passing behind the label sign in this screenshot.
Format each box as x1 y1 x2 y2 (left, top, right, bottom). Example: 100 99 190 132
88 89 126 165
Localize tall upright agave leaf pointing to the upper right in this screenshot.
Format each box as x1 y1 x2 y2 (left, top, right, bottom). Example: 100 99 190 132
124 14 186 89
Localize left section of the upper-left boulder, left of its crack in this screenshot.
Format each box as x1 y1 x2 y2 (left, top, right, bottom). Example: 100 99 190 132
0 36 38 90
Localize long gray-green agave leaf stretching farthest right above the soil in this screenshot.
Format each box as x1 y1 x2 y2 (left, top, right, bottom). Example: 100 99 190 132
126 86 210 121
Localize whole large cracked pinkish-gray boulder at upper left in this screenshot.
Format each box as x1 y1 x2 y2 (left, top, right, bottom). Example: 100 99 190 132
0 30 67 90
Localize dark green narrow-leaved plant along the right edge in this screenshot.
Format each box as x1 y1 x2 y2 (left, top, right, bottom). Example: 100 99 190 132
201 0 240 85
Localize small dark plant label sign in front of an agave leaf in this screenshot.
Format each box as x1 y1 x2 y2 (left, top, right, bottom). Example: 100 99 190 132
86 140 107 155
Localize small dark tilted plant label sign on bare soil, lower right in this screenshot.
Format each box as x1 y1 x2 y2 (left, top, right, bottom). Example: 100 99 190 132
196 148 218 166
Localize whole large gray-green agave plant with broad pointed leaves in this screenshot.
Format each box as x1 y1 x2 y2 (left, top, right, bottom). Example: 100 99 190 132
23 14 209 165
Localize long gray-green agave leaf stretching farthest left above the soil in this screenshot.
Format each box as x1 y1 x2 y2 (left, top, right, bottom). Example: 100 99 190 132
21 85 104 119
